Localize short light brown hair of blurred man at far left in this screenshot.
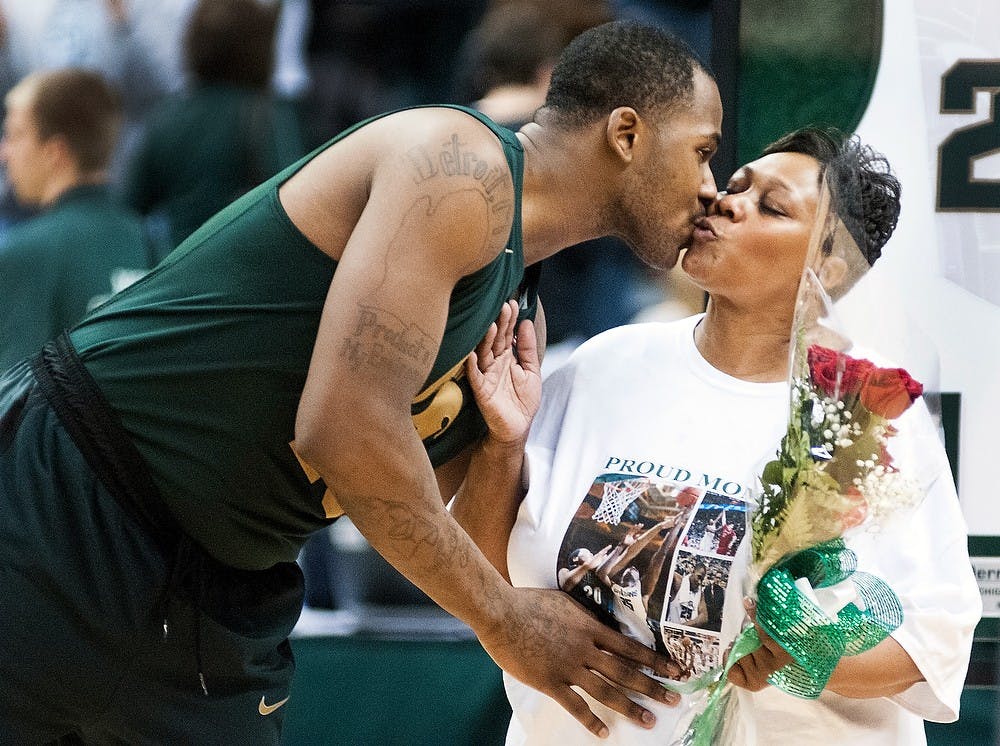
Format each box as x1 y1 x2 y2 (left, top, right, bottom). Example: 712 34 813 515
6 67 122 173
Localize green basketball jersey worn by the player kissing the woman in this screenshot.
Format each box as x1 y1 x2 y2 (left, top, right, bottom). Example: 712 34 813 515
71 107 524 568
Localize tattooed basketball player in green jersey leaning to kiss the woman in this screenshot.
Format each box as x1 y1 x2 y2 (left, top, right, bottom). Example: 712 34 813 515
0 23 722 743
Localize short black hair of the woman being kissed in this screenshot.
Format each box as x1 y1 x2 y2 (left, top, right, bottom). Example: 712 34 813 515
763 127 901 265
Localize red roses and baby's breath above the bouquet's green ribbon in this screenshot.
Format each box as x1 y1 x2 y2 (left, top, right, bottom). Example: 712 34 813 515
751 344 923 578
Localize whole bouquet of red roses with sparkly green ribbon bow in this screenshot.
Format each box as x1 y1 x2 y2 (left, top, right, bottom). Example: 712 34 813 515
677 326 923 746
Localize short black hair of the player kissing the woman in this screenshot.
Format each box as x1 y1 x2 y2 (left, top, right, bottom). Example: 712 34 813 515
543 21 711 127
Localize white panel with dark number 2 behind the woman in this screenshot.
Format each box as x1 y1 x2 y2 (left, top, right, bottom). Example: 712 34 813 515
843 0 1000 535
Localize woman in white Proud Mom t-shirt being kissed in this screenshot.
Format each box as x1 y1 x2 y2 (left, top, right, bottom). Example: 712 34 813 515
453 129 981 746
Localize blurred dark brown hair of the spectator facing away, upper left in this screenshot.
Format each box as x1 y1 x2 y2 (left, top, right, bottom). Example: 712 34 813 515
184 0 281 89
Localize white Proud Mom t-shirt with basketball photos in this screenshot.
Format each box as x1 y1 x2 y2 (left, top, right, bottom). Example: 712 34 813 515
505 316 981 746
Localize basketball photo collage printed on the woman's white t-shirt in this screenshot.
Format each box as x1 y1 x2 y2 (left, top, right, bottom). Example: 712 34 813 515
556 474 747 681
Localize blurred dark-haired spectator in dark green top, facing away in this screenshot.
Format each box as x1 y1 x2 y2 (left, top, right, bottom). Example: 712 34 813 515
124 0 304 256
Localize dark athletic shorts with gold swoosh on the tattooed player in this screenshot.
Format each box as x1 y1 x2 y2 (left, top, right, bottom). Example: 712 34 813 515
0 339 302 744
